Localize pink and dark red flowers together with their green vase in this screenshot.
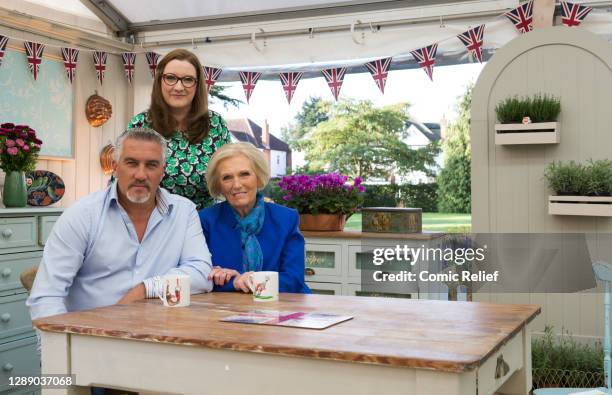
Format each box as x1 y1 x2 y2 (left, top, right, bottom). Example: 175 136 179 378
0 123 42 207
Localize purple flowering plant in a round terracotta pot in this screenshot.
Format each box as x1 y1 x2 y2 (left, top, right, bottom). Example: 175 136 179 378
278 173 365 230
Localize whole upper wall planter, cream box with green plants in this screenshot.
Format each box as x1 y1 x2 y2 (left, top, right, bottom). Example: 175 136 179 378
495 94 561 145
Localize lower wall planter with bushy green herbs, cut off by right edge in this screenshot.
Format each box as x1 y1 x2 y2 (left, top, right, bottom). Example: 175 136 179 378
544 159 612 217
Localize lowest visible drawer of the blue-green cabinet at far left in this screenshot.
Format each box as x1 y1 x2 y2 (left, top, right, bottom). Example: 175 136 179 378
0 336 40 392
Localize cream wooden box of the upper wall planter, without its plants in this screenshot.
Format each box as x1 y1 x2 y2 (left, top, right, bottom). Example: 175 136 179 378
495 122 561 145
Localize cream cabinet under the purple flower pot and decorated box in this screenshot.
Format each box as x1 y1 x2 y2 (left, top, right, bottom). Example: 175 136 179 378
302 231 448 299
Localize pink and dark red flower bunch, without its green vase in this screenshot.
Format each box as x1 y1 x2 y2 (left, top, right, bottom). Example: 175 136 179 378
0 123 42 173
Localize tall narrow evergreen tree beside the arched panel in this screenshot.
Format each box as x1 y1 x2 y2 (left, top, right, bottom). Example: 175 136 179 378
438 85 473 213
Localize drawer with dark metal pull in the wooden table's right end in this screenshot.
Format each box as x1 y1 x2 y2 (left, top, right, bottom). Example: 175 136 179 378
477 329 524 394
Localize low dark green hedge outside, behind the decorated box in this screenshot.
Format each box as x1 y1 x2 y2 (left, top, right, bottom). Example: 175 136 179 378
363 183 438 212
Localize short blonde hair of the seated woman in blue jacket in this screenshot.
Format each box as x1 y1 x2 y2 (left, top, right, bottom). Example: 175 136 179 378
206 143 270 198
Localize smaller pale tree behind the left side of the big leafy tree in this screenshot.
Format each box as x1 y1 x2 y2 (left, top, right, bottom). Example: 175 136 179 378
282 97 331 148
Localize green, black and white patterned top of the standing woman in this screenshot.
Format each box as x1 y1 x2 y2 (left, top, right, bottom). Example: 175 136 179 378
128 111 230 210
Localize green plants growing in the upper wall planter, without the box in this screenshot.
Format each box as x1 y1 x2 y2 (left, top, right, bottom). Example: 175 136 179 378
495 94 561 123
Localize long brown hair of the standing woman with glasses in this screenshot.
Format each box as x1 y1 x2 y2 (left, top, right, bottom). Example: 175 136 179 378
149 49 210 144
